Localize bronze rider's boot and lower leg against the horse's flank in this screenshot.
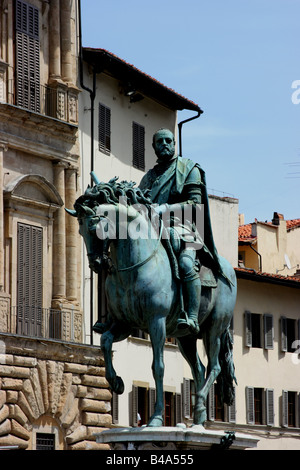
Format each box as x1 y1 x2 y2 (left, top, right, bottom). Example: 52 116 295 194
177 276 201 335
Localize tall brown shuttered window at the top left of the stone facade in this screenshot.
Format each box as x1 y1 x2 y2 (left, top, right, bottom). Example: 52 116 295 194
15 0 40 112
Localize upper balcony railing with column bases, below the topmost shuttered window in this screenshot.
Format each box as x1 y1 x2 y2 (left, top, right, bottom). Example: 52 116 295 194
2 80 78 123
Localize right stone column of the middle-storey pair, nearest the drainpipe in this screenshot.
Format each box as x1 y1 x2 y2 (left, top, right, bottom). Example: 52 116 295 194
66 167 79 301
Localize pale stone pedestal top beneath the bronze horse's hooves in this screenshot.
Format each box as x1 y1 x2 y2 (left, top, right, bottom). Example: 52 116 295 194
96 425 258 452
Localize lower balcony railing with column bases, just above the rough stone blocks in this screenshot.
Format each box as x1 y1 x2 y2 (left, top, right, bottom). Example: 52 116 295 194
10 305 75 342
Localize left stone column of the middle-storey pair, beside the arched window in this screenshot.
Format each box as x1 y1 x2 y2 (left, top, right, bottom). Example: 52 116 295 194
53 162 66 300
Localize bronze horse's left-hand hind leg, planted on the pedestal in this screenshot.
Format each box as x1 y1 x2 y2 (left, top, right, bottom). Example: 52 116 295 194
177 336 206 424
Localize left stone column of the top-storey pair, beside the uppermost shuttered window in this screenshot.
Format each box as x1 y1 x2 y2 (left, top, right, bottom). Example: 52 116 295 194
49 0 61 78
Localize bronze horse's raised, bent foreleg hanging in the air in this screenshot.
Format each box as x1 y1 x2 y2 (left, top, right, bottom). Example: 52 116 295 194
101 324 130 395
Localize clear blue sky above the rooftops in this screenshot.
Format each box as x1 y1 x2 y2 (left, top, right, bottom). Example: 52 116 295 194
81 0 300 223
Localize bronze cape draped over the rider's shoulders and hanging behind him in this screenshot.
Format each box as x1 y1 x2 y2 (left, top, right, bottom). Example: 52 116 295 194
139 157 222 272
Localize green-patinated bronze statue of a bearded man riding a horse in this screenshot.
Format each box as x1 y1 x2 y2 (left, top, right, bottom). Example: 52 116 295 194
67 129 236 426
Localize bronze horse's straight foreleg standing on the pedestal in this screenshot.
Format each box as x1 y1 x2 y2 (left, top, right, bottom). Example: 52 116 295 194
148 317 166 427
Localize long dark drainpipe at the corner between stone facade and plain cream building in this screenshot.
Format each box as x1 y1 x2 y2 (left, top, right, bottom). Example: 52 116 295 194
78 0 96 345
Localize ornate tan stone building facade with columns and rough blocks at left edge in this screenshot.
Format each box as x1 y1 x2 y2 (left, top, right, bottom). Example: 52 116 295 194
0 0 110 450
